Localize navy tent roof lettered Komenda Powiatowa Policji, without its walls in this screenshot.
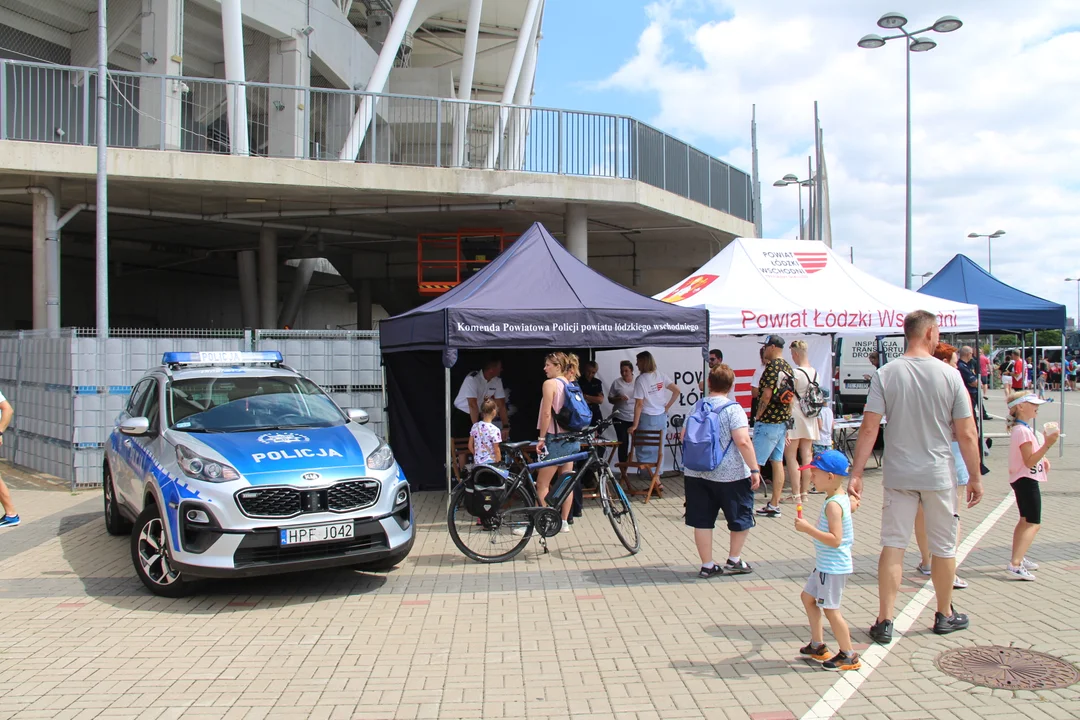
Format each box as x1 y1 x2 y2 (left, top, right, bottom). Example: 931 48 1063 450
379 222 707 352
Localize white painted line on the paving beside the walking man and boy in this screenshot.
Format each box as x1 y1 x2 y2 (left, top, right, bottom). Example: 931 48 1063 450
801 495 1013 720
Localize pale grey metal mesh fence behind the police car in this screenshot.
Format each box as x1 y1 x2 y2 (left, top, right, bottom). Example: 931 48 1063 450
0 328 387 489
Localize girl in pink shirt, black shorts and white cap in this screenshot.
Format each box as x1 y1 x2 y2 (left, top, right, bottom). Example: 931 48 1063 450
1007 392 1061 581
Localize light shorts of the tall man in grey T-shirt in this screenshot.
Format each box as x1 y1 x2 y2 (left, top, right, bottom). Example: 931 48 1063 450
881 488 960 558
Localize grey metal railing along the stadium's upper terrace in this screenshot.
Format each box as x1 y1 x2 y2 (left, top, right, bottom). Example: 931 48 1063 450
0 59 754 221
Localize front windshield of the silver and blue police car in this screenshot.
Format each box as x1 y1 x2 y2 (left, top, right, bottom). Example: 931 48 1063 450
165 376 347 433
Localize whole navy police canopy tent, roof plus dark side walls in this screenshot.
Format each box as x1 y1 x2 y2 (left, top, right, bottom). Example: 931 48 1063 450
379 222 708 488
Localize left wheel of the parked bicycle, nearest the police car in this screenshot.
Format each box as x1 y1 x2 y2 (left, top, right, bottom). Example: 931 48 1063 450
446 484 535 562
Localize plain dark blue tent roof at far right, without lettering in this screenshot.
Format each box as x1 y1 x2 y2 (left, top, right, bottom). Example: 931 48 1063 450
919 255 1065 332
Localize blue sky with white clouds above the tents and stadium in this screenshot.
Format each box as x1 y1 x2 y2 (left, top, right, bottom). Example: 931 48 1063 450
534 0 1080 316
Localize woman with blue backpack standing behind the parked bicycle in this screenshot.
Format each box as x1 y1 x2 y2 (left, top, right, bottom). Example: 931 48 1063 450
531 353 581 533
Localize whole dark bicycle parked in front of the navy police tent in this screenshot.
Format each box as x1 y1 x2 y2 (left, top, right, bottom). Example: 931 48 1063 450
446 419 642 562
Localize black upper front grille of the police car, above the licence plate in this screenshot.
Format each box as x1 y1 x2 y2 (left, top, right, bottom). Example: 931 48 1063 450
237 479 381 518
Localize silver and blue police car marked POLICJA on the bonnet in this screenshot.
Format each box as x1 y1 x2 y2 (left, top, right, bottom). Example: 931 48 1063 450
103 352 416 597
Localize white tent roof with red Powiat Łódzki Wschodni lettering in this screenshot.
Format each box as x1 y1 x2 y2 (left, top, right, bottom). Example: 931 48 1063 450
656 237 978 336
